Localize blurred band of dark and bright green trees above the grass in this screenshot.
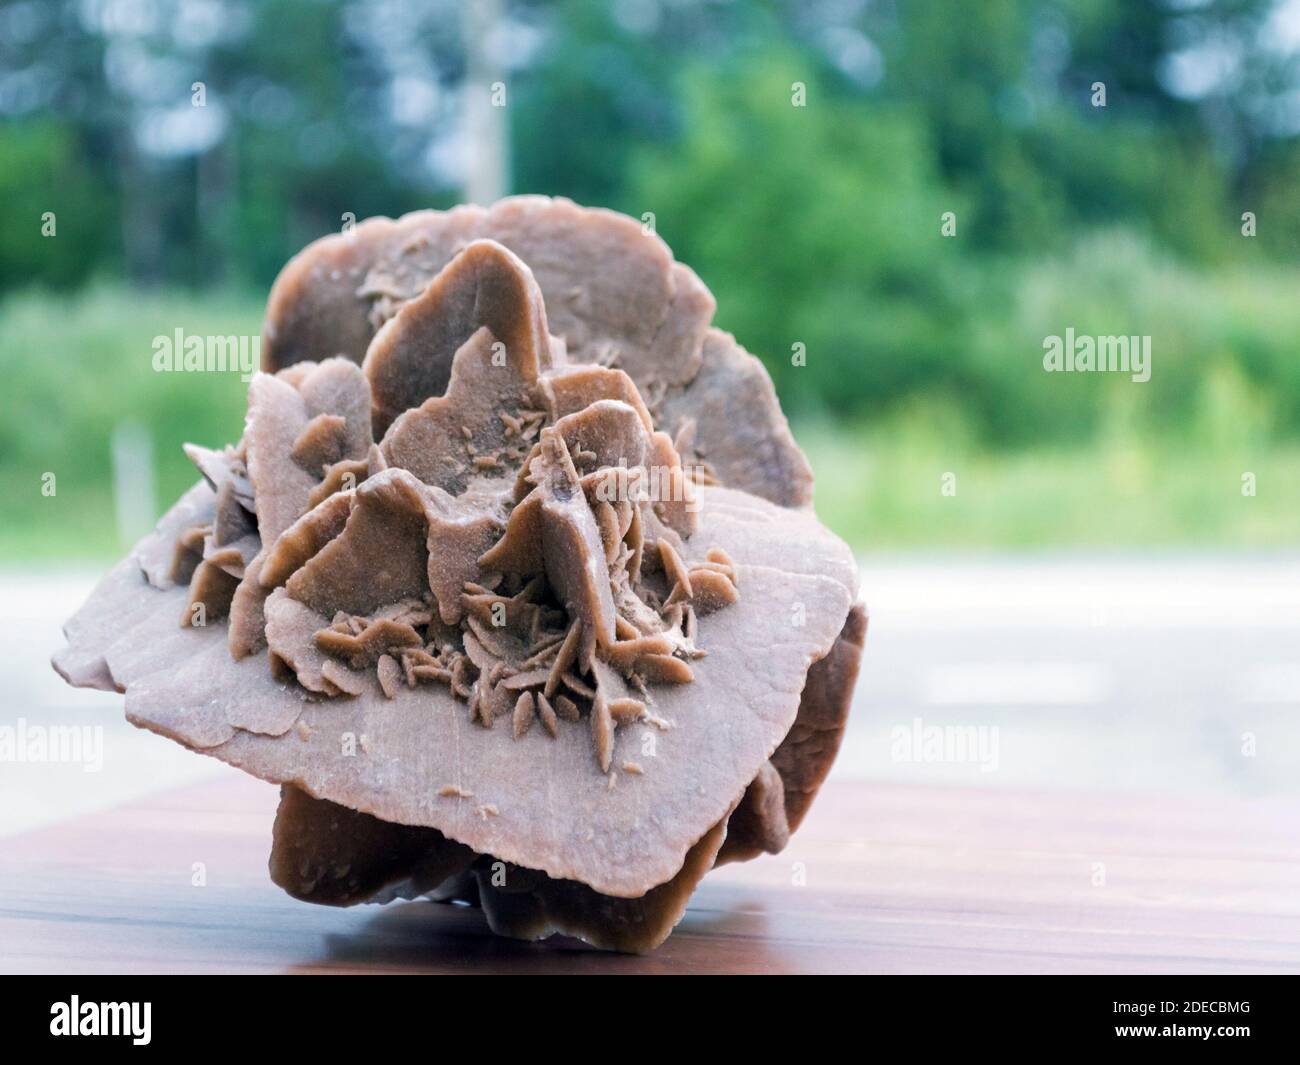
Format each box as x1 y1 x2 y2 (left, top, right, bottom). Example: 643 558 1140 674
0 0 1300 440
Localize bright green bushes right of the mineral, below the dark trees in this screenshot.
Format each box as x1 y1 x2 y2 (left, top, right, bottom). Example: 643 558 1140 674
624 55 1300 445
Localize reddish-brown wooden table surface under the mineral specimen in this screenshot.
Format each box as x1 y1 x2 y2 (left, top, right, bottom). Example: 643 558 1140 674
0 771 1300 973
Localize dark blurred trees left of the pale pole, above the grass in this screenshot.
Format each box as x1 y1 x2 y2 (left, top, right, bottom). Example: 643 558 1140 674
0 0 462 286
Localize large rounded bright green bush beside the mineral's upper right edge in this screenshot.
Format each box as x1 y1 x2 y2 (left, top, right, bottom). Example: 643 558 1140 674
625 52 965 423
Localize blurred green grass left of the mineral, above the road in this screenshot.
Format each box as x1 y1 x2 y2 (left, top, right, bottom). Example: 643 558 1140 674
0 286 263 562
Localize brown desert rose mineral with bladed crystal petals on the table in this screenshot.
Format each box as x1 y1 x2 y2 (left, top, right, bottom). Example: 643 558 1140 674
55 196 866 951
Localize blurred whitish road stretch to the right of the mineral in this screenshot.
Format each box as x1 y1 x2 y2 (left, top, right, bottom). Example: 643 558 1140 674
837 555 1300 796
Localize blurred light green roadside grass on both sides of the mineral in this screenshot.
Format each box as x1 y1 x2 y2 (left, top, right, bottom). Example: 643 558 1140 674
0 287 1300 563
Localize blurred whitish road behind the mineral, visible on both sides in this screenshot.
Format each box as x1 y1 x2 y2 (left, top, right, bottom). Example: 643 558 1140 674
0 555 1300 835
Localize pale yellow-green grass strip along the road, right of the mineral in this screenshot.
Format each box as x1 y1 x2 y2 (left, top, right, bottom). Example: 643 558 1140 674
796 427 1300 551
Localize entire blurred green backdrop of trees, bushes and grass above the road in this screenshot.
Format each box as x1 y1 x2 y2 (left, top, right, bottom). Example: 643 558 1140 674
0 0 1300 551
